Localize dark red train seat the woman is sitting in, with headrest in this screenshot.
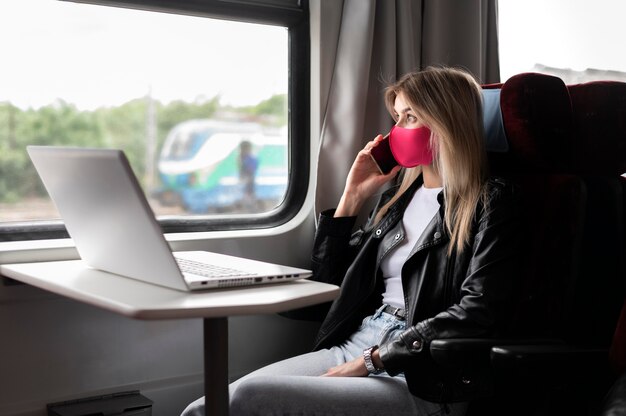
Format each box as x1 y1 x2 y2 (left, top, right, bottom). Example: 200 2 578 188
431 73 586 414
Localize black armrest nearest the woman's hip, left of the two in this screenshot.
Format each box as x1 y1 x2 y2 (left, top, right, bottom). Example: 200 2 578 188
430 338 563 368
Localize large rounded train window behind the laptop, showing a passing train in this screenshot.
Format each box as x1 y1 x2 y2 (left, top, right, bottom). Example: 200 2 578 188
0 0 308 240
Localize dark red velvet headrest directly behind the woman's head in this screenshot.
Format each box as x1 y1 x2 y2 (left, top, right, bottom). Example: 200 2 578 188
496 73 572 173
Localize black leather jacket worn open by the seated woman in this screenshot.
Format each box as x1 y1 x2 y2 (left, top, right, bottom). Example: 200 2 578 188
312 178 519 402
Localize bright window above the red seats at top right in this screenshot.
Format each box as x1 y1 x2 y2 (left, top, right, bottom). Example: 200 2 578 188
498 0 626 84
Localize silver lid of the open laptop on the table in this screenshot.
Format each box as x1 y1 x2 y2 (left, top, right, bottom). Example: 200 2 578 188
27 146 187 290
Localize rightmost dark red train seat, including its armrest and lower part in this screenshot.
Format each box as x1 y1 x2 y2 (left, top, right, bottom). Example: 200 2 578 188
472 81 626 415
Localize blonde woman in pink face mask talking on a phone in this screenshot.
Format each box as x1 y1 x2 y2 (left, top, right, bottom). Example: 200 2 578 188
184 68 518 415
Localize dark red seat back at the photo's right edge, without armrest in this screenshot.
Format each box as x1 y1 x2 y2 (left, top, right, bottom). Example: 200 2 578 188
568 81 626 347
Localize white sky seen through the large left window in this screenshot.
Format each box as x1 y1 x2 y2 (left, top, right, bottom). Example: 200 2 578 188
0 0 288 110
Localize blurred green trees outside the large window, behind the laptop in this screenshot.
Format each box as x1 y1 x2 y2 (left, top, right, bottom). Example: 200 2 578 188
0 95 287 203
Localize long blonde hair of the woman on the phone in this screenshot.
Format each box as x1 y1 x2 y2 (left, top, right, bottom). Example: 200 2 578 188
375 67 488 255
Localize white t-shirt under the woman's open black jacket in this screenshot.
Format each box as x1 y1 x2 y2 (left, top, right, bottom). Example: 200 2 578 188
380 186 443 308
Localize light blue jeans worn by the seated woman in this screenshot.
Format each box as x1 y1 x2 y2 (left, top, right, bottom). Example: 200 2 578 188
182 307 467 416
